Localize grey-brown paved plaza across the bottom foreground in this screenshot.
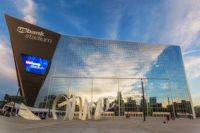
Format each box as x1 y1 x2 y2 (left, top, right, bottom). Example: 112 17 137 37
0 116 200 133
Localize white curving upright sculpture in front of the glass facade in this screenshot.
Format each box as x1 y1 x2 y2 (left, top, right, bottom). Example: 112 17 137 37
52 94 115 120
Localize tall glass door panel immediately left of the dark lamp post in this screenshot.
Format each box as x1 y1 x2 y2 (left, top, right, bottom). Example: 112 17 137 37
118 79 142 117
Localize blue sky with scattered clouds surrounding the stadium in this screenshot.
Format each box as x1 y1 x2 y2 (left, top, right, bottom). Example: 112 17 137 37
0 0 200 104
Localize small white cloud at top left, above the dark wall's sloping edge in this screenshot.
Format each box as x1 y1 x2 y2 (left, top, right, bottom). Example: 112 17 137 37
14 0 37 24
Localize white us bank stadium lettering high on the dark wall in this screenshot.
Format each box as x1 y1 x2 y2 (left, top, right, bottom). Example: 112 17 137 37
17 26 52 44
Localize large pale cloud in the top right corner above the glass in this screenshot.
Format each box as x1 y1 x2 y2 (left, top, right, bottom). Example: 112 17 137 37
161 0 200 51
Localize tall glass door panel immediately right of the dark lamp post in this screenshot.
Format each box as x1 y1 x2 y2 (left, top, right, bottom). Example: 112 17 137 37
144 79 173 116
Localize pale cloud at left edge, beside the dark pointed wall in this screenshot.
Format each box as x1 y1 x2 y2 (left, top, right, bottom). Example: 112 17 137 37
0 35 18 99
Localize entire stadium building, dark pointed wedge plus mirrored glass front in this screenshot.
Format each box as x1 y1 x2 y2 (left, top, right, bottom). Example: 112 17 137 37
6 15 194 116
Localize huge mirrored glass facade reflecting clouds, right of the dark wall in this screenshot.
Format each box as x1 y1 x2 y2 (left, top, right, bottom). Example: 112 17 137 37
35 36 192 116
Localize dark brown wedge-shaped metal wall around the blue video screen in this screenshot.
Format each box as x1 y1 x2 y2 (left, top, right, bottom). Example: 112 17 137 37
5 15 60 106
